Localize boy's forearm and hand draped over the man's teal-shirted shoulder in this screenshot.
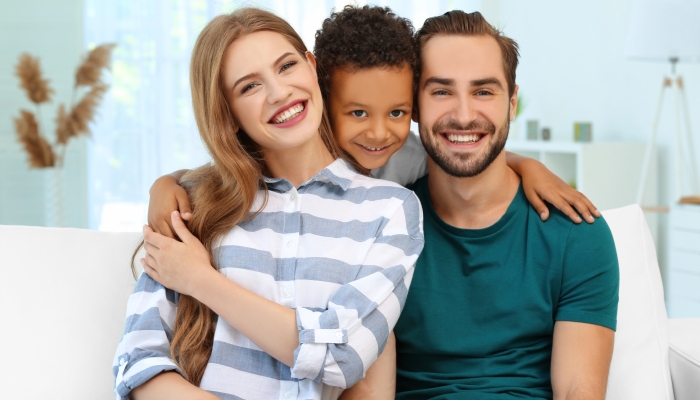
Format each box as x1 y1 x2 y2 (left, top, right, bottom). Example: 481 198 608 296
506 151 600 224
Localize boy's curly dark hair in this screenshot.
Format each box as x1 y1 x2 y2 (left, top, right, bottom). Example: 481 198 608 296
314 5 418 102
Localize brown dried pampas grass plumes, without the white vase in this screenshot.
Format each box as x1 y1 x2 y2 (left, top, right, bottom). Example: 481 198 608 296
14 44 115 168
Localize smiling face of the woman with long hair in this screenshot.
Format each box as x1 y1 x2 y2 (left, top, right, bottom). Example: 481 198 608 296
222 31 323 150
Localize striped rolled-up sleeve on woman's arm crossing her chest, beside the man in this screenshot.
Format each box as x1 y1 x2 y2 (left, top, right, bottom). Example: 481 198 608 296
292 191 424 388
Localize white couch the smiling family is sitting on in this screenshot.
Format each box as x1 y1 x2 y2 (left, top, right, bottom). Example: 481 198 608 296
0 206 700 400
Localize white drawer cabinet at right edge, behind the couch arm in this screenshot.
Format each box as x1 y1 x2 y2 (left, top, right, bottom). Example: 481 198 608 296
666 204 700 318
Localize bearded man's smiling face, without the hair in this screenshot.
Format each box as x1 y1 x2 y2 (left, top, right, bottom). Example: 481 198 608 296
418 35 518 177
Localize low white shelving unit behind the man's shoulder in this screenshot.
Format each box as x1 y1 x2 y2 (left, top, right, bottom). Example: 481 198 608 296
506 140 658 212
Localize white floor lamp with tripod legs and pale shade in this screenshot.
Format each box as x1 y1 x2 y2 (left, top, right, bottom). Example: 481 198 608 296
626 0 700 204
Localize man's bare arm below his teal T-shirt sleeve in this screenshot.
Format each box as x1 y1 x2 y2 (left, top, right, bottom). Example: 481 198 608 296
552 321 615 400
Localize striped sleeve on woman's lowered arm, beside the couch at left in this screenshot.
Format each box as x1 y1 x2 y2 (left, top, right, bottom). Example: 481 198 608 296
112 273 184 400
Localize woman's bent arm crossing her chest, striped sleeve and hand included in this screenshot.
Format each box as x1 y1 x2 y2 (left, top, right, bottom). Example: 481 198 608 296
142 192 423 388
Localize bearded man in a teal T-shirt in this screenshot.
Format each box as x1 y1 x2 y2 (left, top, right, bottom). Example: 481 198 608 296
346 11 619 400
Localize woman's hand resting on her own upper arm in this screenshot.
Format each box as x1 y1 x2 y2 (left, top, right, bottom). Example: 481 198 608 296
141 211 216 296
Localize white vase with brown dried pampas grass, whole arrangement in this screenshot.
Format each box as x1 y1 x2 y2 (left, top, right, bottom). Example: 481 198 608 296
14 44 115 227
